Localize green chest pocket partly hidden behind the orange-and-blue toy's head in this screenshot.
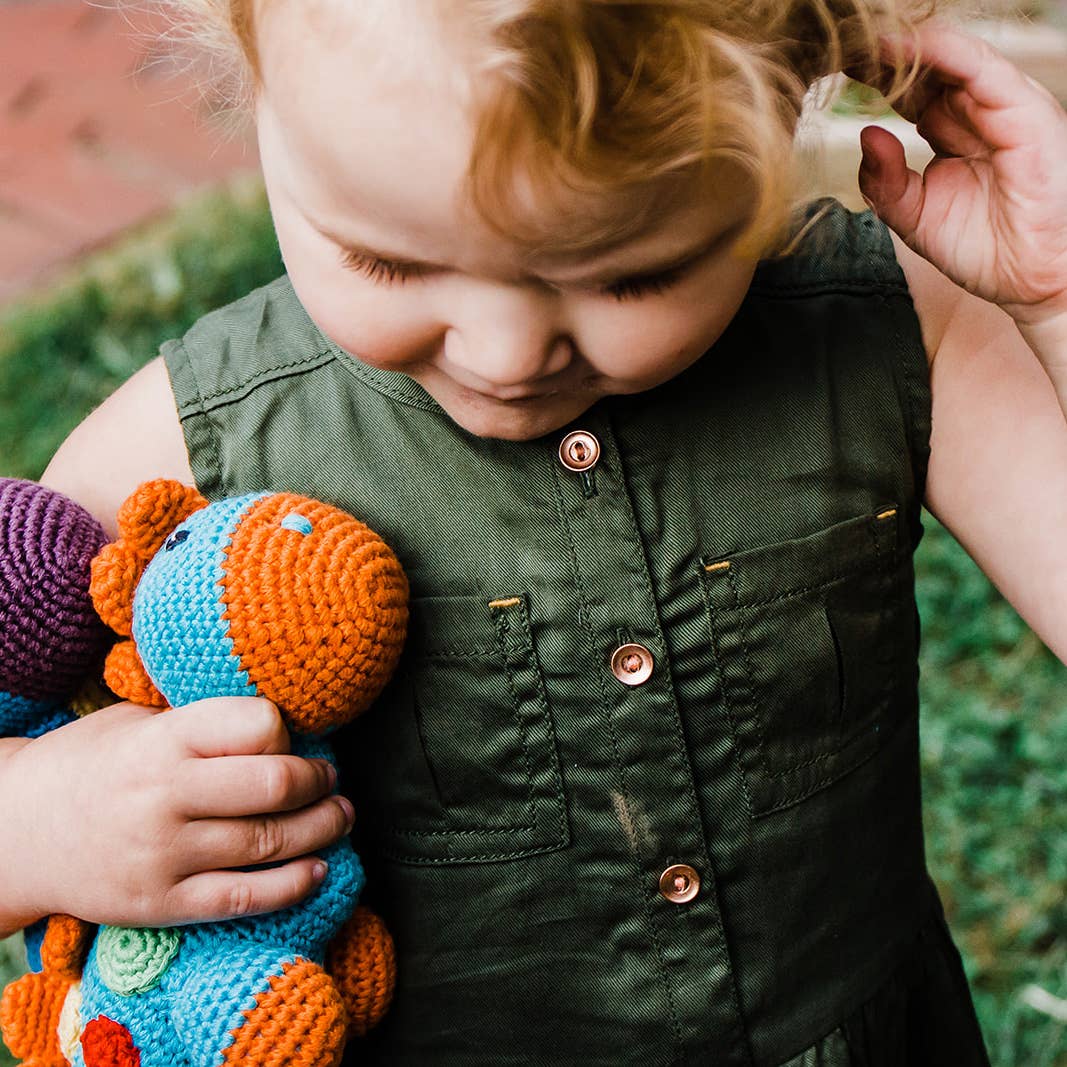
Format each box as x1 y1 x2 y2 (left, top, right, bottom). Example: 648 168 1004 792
354 596 569 863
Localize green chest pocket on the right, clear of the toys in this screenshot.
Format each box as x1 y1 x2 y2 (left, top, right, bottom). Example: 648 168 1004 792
701 505 918 815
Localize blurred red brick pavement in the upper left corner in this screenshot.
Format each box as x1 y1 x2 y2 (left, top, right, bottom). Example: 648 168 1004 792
0 0 256 301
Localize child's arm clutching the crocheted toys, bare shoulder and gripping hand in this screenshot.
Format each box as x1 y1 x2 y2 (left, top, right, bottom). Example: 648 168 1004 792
0 363 351 935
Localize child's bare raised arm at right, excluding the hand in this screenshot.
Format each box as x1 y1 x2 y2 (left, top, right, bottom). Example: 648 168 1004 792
897 248 1067 663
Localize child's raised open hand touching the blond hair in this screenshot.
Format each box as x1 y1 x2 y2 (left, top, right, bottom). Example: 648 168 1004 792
859 22 1067 341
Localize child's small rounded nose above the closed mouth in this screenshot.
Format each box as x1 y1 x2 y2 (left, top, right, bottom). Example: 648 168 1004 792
445 286 574 389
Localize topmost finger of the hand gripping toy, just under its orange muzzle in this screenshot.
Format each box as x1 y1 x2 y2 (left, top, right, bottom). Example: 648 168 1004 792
164 697 289 758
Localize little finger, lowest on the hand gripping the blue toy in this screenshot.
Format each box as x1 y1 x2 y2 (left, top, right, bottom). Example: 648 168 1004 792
161 857 325 925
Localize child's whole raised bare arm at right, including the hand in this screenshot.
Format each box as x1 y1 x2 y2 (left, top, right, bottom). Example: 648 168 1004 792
860 26 1067 662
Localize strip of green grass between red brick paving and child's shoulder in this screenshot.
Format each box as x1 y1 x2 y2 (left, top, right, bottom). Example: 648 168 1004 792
0 172 283 477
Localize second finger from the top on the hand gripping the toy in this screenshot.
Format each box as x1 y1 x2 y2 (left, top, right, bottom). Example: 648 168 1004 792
175 754 337 818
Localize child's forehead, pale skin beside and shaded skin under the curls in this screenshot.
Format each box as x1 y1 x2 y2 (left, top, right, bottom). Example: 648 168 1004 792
251 0 747 262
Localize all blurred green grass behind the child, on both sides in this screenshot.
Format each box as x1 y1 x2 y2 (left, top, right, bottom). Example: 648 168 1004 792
0 185 1067 1067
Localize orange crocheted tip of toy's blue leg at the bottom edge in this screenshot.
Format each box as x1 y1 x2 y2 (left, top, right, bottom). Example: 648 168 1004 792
223 958 348 1067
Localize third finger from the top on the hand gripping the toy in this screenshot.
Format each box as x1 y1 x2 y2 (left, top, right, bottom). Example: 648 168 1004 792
174 796 354 874
